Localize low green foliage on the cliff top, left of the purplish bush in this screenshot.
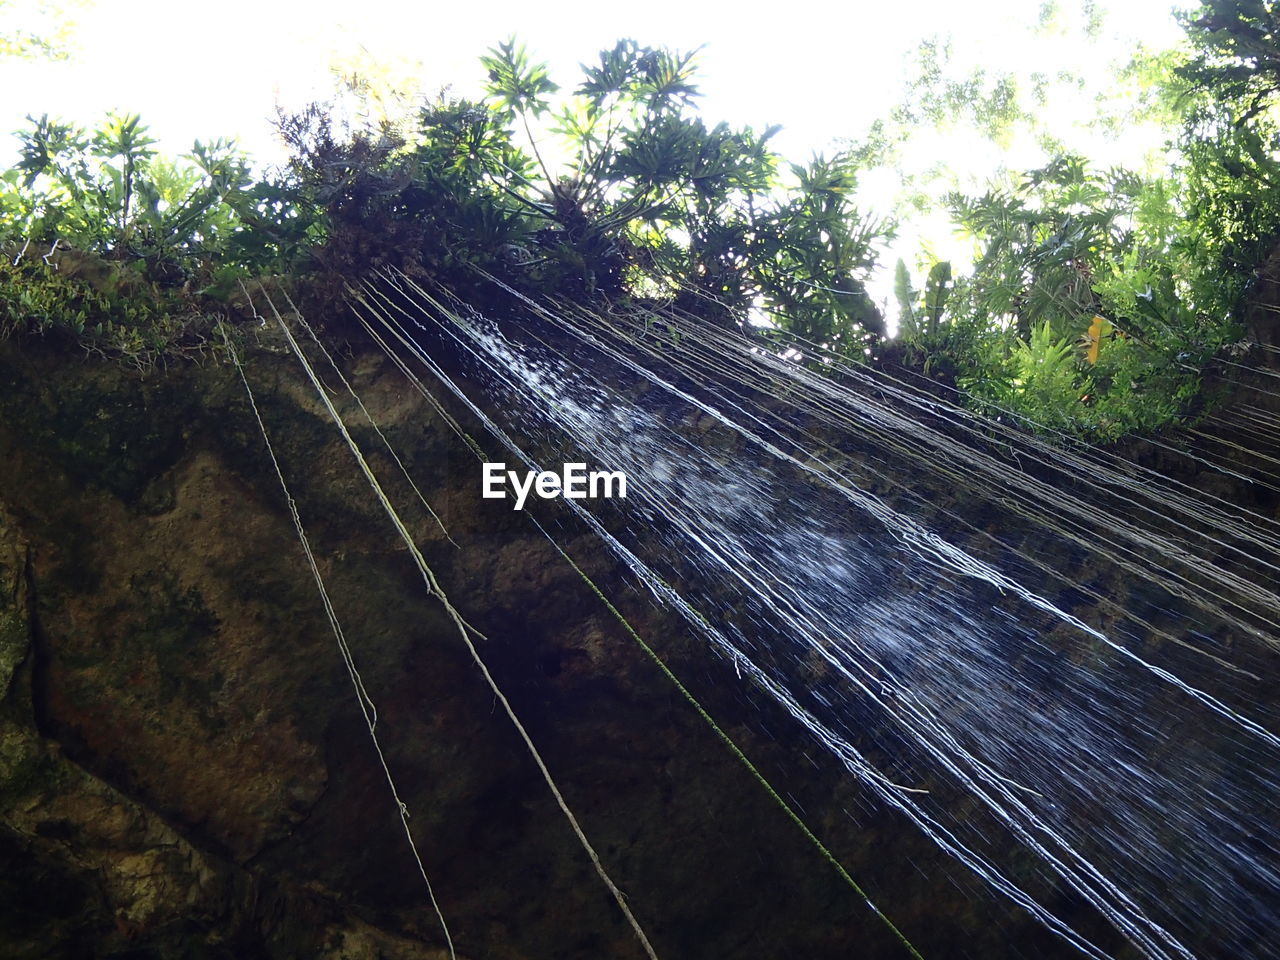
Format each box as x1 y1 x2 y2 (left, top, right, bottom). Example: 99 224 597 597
0 115 297 366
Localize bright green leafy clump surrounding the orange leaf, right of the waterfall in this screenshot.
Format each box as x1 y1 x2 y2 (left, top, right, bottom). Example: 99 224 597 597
897 144 1236 439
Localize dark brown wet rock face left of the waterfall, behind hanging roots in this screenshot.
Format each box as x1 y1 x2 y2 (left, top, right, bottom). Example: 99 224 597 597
0 330 1269 960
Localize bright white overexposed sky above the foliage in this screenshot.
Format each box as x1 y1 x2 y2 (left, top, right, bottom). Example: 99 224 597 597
0 0 1187 300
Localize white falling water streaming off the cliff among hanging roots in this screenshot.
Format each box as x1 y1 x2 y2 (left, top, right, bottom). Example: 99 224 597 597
332 279 1280 957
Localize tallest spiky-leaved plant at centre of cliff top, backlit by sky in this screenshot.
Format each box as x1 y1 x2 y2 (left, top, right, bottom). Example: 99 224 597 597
485 40 773 296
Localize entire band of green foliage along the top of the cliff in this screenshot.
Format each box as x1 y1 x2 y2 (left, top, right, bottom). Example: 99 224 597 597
0 17 1280 439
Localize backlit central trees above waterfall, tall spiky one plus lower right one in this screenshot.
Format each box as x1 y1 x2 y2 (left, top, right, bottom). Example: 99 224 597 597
465 40 890 349
